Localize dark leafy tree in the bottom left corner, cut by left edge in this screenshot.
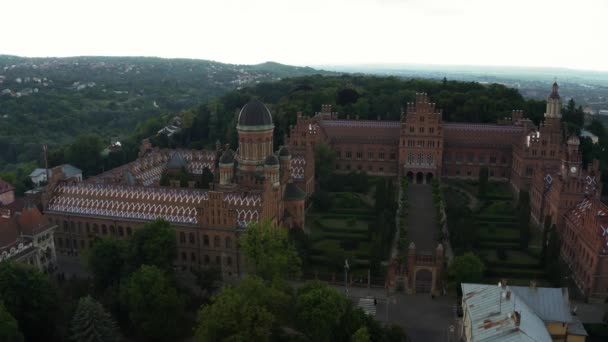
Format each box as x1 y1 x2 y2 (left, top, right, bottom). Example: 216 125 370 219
0 261 59 341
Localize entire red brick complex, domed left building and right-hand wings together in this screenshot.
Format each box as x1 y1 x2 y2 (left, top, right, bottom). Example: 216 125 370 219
43 84 600 294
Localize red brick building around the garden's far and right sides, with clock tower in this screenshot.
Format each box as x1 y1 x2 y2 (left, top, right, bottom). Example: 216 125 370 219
288 83 608 291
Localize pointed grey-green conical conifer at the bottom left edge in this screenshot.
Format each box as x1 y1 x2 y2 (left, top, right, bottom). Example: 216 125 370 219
71 296 121 342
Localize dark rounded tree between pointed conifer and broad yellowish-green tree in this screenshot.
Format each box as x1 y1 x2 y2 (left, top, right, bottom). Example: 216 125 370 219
120 265 184 341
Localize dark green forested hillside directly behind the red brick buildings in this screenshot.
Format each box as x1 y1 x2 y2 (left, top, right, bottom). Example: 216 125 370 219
7 75 608 198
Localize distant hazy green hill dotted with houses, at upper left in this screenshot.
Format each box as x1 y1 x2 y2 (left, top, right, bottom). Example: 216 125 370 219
0 55 332 171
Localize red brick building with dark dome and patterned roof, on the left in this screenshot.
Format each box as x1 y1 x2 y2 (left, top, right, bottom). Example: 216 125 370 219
43 101 314 277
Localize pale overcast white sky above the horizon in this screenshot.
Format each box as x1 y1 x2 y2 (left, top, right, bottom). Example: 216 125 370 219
0 0 608 71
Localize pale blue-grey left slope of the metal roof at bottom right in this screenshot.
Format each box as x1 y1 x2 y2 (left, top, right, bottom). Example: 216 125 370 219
462 284 551 342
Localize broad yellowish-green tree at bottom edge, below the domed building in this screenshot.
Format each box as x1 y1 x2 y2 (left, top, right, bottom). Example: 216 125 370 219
195 276 289 342
